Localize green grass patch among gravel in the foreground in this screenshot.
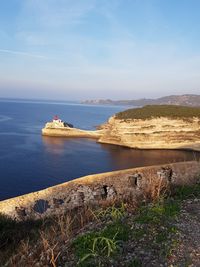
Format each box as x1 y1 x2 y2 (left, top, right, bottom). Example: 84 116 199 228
73 198 180 267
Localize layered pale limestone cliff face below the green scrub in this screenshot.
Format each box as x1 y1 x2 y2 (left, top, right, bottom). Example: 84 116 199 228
99 116 200 151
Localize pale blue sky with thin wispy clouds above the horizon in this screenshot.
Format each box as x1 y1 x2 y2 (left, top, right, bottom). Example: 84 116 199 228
0 0 200 100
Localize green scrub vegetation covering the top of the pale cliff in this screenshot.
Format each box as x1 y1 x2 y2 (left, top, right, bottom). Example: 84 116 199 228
116 105 200 119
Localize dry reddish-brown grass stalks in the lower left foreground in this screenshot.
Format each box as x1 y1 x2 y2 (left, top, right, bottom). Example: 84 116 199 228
7 207 95 267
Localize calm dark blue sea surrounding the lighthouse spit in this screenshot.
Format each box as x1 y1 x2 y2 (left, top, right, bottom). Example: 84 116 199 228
0 99 200 200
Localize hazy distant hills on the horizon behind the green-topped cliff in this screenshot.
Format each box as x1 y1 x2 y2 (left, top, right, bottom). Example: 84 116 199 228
81 94 200 106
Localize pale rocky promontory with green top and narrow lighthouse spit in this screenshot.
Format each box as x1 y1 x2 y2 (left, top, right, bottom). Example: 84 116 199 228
42 105 200 151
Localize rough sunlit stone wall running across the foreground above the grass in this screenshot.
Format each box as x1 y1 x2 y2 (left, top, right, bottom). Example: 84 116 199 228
0 161 200 220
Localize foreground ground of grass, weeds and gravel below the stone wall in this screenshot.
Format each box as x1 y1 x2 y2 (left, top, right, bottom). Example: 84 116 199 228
0 178 200 267
